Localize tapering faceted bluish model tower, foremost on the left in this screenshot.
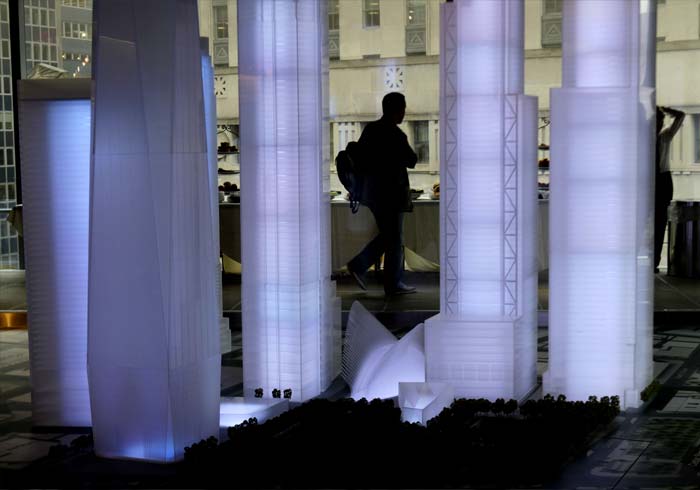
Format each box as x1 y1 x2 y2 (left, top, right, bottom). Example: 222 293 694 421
88 0 221 462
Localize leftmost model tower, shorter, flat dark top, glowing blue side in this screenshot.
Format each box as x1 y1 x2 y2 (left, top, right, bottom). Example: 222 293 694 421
19 79 91 426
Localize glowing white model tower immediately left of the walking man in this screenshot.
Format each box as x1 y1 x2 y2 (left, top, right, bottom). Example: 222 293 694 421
238 0 338 401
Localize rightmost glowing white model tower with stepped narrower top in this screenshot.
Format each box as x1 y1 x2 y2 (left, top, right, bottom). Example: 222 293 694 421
544 0 656 407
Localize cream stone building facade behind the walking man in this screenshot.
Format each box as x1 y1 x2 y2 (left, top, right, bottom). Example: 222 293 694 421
199 0 700 199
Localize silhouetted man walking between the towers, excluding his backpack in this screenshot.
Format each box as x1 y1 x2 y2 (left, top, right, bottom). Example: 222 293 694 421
348 92 418 295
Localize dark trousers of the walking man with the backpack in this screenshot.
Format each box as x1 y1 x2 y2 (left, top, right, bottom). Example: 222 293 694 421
348 207 403 293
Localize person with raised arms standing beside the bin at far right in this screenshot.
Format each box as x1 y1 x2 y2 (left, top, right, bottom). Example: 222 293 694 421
654 106 685 273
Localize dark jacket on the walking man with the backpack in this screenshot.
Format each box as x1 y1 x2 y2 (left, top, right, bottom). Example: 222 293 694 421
359 118 418 212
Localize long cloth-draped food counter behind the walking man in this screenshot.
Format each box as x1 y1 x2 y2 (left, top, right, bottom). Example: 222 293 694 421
219 199 549 271
